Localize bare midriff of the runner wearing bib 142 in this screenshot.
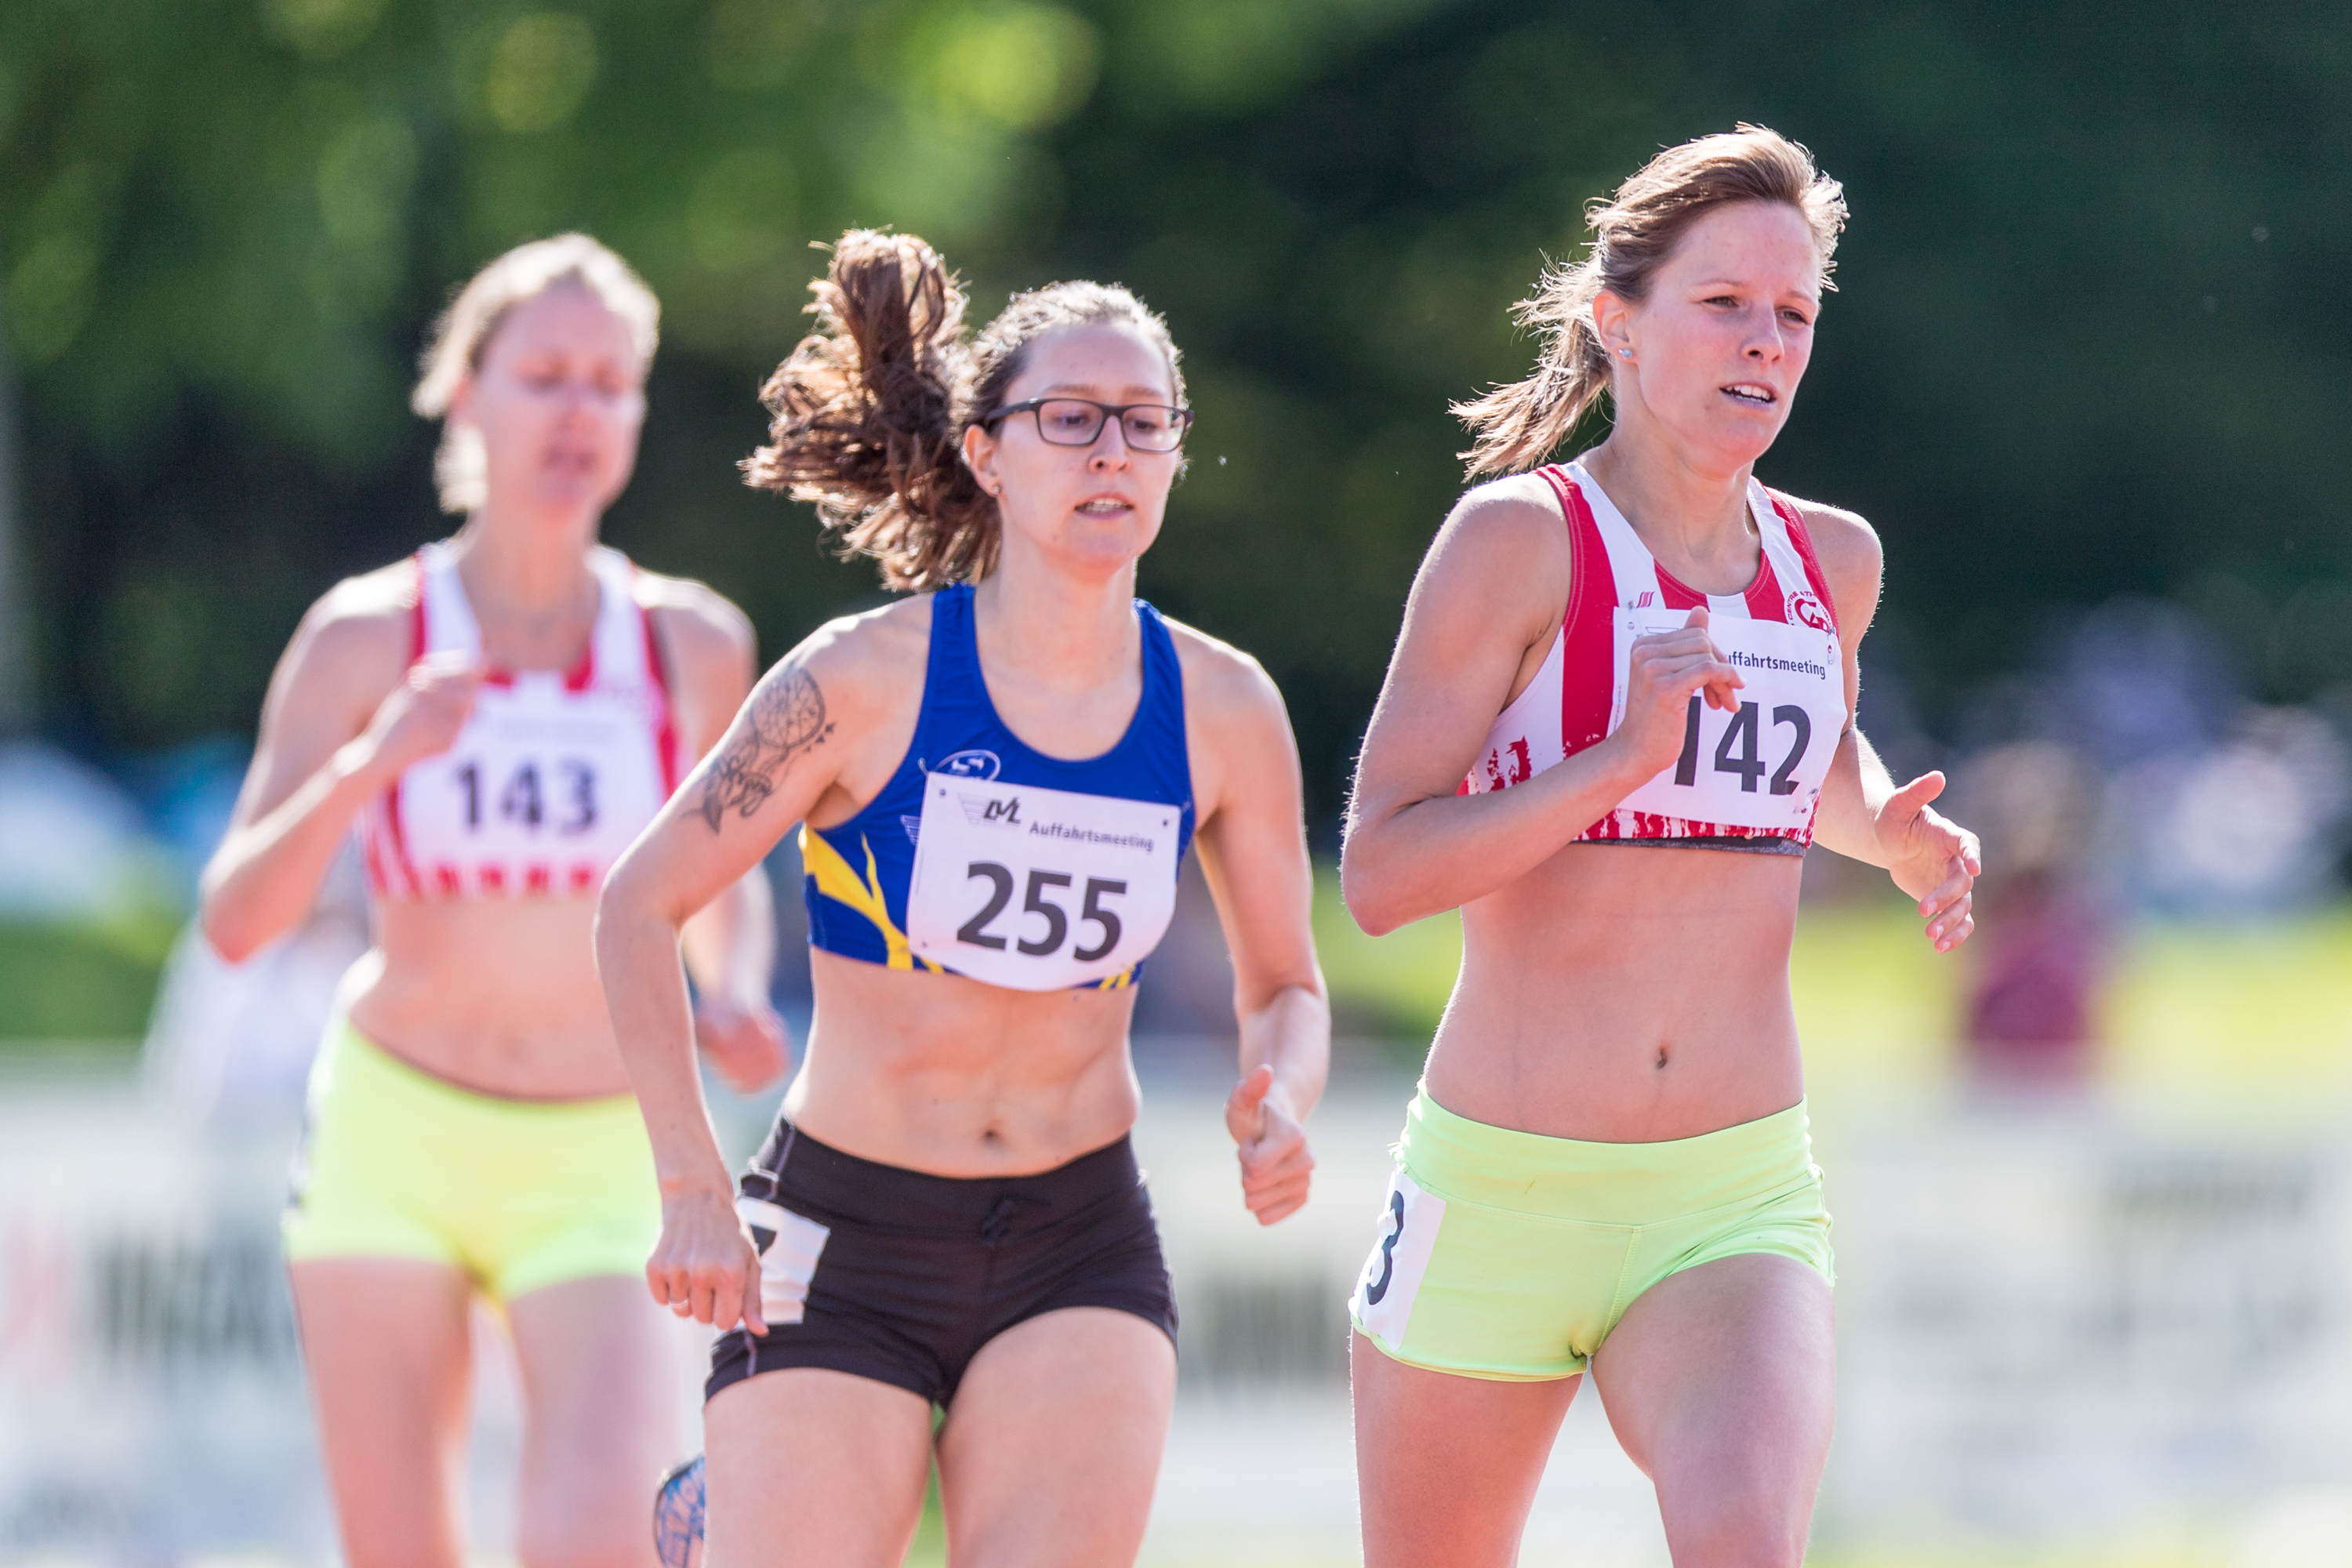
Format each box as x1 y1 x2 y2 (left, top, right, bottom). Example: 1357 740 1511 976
1428 844 1804 1142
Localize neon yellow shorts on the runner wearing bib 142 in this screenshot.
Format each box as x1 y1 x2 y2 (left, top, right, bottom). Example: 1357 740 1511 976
1348 1088 1837 1382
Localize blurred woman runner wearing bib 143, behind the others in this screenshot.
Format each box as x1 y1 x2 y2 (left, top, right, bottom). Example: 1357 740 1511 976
202 235 783 1568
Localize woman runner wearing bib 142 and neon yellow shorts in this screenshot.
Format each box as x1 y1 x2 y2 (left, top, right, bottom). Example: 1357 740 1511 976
1343 127 1978 1568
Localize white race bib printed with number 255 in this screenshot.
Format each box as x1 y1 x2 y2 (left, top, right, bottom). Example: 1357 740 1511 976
906 774 1183 992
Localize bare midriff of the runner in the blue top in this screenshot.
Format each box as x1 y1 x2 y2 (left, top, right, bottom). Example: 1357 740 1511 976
783 947 1143 1175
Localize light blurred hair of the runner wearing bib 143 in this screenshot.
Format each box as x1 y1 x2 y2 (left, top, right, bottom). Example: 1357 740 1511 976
409 235 661 513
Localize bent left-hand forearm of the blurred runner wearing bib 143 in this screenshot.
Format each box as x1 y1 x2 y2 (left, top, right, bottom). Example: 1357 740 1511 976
198 741 386 964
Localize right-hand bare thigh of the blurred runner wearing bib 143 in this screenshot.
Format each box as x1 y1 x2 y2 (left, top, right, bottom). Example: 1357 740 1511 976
506 1274 684 1568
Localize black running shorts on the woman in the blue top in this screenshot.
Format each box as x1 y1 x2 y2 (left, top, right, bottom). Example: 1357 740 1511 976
706 1116 1176 1406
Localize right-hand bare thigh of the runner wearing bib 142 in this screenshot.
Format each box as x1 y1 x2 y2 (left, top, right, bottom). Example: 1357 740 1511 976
1592 1253 1837 1568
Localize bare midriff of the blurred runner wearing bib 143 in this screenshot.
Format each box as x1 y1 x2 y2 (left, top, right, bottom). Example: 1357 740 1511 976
343 898 628 1100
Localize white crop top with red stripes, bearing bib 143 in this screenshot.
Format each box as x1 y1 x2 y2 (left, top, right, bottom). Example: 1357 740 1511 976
360 543 687 898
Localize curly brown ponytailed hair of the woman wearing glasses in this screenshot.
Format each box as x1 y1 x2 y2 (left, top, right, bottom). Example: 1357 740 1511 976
743 228 1183 593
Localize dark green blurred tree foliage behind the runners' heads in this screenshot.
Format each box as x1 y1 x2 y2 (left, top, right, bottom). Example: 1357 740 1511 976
0 0 2352 820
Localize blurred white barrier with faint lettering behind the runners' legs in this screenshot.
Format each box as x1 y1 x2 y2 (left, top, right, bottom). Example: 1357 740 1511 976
13 1074 2352 1568
